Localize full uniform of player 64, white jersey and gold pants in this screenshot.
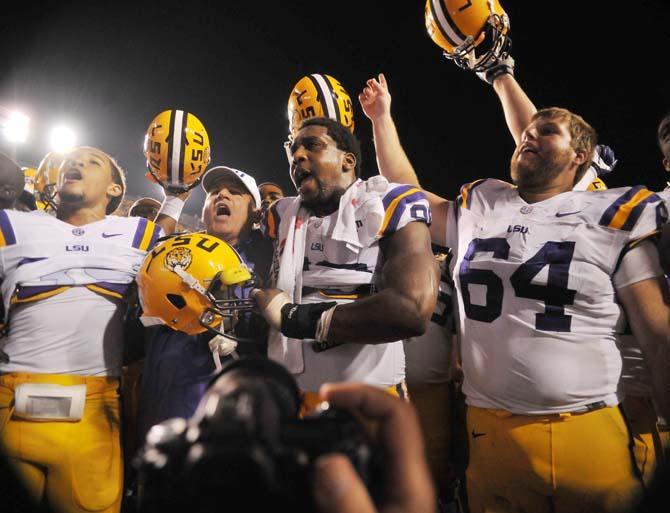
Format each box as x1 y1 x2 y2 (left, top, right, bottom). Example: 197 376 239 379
447 179 665 512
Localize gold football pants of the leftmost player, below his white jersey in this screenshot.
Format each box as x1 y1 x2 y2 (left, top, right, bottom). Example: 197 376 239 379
0 373 123 513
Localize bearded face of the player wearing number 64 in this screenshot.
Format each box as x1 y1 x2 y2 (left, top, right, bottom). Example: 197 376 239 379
510 118 576 189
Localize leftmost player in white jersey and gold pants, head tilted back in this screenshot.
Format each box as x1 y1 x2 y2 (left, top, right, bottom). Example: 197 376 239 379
0 147 161 513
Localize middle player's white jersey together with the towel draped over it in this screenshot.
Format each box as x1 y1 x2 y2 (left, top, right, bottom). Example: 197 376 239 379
264 176 430 404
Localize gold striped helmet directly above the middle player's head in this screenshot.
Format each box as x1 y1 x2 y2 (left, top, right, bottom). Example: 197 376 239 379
288 73 354 138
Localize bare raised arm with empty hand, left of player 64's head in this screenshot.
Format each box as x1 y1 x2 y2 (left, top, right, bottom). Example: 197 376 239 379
358 73 450 246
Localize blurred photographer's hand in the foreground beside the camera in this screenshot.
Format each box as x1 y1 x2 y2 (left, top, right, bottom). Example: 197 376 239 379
313 383 436 513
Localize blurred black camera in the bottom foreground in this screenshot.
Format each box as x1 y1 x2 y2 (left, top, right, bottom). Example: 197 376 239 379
136 357 385 513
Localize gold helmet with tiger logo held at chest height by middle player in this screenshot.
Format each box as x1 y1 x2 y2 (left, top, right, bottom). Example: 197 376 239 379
137 233 254 337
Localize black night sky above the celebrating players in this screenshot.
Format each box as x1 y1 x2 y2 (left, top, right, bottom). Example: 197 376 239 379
0 0 670 212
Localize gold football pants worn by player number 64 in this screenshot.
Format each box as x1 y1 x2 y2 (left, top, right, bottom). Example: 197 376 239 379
466 406 642 513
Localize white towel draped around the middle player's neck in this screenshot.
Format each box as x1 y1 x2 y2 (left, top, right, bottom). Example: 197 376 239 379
268 176 388 374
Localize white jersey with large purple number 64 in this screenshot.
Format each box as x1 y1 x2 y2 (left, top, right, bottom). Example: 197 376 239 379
447 179 667 414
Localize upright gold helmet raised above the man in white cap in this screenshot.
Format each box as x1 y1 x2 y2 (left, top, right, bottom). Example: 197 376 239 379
144 109 211 192
